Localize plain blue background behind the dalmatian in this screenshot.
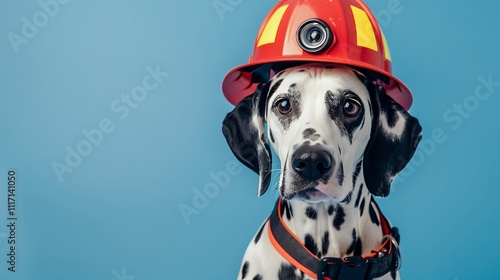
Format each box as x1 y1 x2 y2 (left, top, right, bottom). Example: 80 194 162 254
0 0 500 280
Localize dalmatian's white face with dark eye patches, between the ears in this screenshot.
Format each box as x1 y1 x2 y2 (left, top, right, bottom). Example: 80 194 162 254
266 67 373 202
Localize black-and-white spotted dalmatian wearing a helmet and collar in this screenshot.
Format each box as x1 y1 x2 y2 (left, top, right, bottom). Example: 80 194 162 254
223 64 422 280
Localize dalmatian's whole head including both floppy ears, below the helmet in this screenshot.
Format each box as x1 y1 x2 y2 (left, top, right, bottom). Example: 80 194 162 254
223 65 421 202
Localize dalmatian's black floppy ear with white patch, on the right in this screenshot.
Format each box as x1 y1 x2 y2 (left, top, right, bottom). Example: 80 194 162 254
363 84 422 197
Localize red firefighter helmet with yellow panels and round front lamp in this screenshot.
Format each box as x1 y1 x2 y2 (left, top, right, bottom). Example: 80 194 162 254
222 0 413 109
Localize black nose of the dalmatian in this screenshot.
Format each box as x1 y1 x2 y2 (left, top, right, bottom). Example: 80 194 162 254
292 146 332 181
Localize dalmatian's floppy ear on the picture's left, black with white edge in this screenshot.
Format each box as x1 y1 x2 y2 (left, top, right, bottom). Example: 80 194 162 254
222 83 272 196
